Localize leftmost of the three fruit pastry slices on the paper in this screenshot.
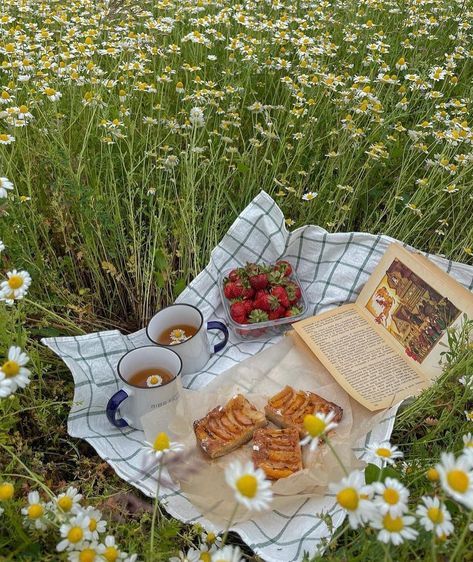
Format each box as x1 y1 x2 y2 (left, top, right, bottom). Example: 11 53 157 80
194 394 268 459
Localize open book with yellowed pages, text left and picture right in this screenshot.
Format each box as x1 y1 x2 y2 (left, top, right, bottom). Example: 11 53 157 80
292 244 473 411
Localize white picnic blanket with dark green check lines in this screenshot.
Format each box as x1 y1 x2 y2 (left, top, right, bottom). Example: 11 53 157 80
42 192 473 562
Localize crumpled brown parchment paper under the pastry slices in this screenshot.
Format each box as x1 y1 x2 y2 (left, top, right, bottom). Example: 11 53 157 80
142 332 392 523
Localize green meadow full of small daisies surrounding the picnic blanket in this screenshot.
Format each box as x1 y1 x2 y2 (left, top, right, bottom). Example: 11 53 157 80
0 0 473 560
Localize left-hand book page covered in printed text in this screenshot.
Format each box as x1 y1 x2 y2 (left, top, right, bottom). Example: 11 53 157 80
293 305 427 410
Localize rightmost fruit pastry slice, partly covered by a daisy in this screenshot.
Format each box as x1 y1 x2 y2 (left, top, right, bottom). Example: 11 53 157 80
264 386 343 437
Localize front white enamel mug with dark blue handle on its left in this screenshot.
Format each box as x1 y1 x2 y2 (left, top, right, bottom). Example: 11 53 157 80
106 345 182 429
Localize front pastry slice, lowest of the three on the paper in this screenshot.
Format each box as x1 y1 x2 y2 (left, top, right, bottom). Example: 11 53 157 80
253 427 302 480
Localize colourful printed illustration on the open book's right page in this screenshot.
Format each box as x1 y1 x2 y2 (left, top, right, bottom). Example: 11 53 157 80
365 258 461 363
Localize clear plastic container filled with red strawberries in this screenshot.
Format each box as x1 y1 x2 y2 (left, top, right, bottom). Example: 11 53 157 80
220 260 307 339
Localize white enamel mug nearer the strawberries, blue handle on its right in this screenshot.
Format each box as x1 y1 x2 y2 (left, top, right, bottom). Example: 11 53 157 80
146 304 228 375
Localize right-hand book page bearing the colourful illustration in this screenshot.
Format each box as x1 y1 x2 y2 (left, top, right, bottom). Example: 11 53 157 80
356 244 473 380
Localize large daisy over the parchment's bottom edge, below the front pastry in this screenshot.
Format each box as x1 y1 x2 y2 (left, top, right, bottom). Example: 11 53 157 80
225 461 273 511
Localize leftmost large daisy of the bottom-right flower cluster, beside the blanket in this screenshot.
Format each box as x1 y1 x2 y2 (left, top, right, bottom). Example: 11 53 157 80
329 470 373 529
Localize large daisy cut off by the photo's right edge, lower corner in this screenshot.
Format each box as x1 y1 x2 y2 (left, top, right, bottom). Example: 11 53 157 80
435 453 473 509
